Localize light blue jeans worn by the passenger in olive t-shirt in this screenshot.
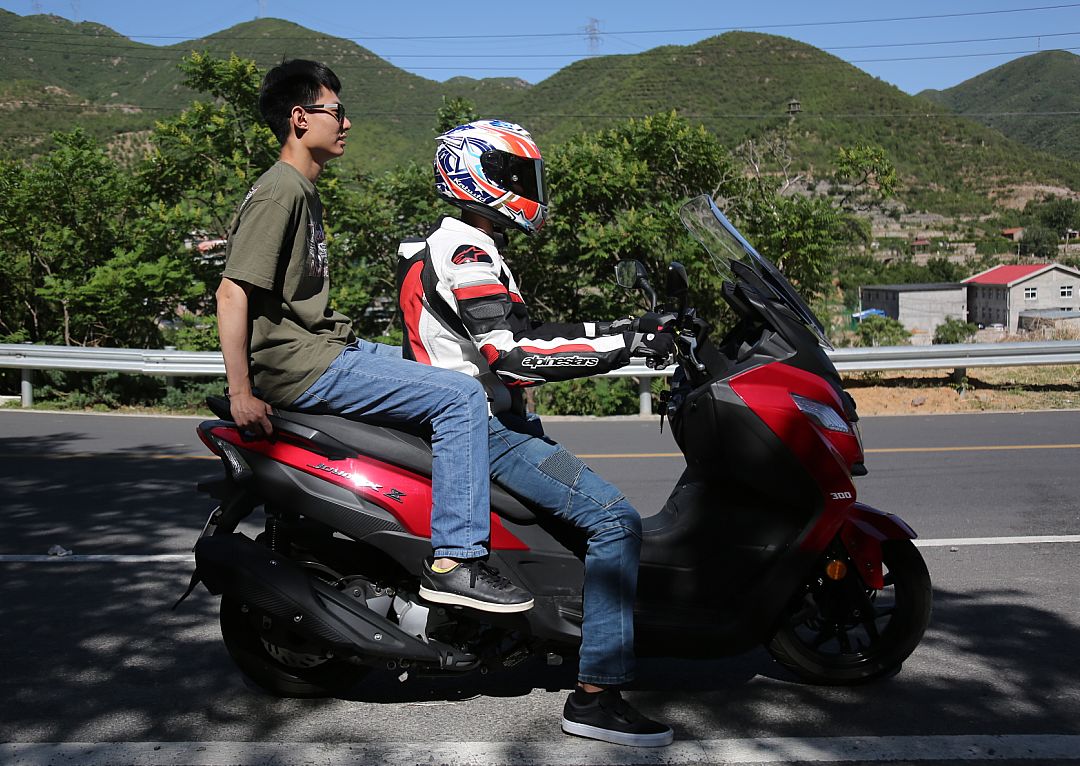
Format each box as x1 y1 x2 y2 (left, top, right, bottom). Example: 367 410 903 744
292 340 491 559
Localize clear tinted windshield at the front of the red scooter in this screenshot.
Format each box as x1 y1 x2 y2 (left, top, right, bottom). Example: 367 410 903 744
679 194 833 349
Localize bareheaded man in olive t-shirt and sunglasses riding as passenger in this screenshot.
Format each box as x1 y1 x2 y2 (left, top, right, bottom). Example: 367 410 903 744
217 59 532 613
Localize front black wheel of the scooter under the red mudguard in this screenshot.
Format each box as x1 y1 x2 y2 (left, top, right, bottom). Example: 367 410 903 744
768 540 933 685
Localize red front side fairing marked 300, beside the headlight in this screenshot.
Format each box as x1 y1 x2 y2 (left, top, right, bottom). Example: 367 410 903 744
731 362 863 551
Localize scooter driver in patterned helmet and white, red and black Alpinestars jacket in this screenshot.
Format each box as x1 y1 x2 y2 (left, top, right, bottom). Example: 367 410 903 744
397 120 674 747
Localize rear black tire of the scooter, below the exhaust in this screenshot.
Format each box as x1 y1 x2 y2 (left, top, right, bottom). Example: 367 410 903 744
220 595 370 697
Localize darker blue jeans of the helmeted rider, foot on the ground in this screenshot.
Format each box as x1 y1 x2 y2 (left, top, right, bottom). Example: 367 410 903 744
488 413 642 686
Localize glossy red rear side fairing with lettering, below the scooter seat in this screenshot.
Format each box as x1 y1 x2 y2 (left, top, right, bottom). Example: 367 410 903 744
213 427 528 551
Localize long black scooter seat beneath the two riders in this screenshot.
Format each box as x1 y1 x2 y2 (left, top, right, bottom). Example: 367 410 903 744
210 398 537 524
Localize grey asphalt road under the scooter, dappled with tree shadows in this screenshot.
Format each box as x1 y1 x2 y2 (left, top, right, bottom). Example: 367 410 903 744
0 412 1080 764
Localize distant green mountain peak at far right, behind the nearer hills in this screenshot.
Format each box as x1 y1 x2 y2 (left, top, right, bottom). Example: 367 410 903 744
919 51 1080 160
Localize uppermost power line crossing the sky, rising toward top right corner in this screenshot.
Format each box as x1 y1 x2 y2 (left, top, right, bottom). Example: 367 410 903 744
6 3 1080 41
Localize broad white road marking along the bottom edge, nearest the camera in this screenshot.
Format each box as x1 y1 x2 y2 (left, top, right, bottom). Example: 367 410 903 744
6 735 1080 766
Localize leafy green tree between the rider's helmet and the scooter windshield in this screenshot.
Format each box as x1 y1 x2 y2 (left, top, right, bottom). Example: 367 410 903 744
522 113 746 320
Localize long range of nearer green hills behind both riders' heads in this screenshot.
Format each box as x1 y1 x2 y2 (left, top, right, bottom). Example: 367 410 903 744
0 11 1080 210
